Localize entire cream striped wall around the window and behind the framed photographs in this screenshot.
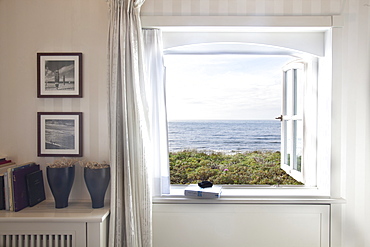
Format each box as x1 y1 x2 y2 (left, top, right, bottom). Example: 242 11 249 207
0 0 370 247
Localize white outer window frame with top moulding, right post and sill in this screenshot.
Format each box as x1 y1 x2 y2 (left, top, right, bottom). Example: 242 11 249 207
142 16 341 200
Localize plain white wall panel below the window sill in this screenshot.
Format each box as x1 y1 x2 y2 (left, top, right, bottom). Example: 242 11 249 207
153 204 330 247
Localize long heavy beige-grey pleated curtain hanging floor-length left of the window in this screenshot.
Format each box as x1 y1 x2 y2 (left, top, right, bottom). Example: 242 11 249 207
108 0 152 247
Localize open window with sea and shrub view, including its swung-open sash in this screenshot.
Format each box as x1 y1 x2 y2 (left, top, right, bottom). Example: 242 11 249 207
165 46 317 186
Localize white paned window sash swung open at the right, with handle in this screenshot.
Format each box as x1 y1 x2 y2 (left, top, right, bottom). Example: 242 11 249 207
280 59 318 186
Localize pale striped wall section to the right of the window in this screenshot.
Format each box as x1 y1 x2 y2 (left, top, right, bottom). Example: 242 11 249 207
336 0 370 247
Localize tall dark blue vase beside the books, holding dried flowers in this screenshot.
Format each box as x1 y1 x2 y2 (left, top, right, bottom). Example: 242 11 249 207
46 166 75 208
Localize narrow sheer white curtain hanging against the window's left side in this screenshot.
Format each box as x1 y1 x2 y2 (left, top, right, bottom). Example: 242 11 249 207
143 28 170 196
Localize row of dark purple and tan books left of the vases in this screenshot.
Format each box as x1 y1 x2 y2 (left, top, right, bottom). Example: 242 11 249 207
0 161 45 212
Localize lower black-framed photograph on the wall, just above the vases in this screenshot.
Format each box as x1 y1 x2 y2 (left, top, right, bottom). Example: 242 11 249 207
37 112 82 157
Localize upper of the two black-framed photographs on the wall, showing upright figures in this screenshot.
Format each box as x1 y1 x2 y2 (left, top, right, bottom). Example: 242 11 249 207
37 53 82 98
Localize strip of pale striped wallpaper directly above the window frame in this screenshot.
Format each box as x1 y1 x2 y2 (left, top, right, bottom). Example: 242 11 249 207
141 0 345 16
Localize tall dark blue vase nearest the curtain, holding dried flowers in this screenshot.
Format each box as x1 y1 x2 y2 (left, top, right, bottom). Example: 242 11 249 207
84 167 110 208
